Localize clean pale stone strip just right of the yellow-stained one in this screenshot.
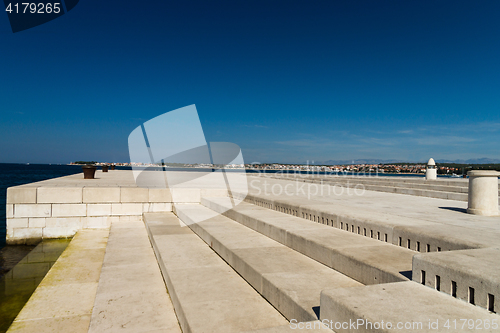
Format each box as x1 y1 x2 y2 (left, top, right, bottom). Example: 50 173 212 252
88 221 181 333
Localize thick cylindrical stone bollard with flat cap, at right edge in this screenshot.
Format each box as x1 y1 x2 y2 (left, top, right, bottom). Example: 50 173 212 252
467 170 500 216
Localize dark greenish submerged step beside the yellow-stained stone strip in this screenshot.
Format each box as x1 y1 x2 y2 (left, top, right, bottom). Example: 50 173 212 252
0 239 71 333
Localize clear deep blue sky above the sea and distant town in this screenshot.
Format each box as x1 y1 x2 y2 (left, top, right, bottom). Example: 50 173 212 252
0 0 500 163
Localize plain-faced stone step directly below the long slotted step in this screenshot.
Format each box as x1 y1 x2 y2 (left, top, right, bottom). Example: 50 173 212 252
202 198 415 284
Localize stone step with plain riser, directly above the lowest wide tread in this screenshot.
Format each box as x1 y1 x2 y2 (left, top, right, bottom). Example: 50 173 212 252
175 205 362 322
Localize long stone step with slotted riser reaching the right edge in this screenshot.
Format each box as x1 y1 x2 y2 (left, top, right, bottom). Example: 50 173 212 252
232 192 500 252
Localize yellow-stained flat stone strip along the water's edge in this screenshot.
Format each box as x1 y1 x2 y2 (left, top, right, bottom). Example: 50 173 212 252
8 230 109 333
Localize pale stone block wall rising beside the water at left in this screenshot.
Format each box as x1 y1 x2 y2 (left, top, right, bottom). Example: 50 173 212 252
6 184 227 244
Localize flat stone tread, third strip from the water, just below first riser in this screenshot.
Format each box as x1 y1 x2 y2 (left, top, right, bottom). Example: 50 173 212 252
144 213 292 333
